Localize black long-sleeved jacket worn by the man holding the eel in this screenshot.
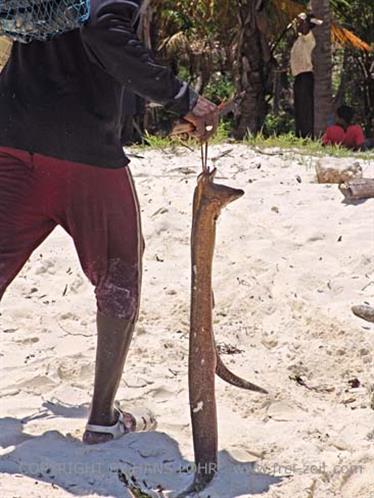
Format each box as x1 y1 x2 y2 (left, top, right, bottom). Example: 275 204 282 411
0 0 197 168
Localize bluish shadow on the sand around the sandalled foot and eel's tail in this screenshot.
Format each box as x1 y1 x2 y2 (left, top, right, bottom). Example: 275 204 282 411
0 403 282 498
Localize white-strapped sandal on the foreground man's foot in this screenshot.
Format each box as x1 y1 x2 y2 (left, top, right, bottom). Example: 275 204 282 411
83 404 157 444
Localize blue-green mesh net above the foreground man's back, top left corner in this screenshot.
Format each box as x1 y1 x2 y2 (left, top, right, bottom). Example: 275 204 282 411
0 0 90 43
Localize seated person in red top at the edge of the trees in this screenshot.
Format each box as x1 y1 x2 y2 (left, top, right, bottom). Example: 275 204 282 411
322 105 365 150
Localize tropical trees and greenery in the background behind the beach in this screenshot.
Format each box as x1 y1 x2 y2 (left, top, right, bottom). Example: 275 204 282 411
139 0 374 139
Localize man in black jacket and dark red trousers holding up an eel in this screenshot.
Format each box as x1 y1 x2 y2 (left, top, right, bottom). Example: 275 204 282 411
0 0 218 444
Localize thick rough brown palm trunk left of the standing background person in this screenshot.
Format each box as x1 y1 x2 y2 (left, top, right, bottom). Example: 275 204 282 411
234 0 266 139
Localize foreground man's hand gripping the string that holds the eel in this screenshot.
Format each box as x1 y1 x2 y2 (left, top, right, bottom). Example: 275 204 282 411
183 96 219 142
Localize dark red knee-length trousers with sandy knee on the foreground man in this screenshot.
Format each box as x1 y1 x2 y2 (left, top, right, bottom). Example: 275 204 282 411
0 147 143 320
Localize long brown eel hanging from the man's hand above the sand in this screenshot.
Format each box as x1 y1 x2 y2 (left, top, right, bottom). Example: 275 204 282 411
180 169 267 496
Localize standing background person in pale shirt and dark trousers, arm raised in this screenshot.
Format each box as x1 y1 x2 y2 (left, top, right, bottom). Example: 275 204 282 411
291 13 322 138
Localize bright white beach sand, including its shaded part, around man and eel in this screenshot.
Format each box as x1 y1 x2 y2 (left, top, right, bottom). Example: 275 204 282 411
0 145 374 498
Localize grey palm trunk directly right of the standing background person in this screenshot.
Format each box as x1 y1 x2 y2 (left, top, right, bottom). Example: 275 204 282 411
312 0 333 137
